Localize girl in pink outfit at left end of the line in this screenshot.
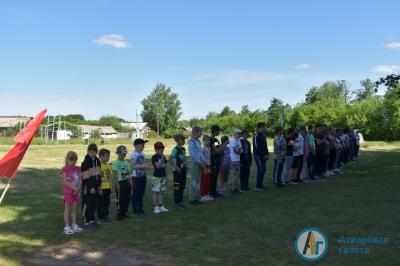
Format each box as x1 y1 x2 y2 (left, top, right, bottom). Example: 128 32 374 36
61 151 83 235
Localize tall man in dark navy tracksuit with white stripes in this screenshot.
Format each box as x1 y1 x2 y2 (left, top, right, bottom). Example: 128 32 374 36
253 122 269 191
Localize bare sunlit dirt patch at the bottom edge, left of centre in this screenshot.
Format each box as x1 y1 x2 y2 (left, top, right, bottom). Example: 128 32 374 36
28 241 176 266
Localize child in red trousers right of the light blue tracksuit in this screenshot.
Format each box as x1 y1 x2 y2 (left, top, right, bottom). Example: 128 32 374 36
200 135 214 202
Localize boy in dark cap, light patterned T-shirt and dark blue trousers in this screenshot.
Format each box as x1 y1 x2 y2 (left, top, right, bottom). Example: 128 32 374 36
130 138 147 216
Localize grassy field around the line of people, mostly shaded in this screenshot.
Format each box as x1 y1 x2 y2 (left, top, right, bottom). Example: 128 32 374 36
0 141 400 265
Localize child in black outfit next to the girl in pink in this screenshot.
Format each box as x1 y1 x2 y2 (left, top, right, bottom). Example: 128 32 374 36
81 144 101 229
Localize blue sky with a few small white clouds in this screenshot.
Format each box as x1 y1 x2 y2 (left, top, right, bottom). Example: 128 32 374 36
0 0 400 121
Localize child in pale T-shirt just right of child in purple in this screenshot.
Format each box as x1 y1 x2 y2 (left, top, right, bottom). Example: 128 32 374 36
229 129 243 193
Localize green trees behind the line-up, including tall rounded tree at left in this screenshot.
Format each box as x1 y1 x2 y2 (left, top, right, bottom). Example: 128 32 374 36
142 75 400 140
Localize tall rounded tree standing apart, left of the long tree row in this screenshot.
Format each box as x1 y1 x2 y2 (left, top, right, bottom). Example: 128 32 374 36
141 83 182 134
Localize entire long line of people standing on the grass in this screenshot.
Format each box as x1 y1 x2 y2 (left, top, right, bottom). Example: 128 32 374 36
61 123 360 234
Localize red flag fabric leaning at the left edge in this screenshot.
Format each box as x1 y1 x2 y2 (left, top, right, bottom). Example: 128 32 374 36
0 109 47 179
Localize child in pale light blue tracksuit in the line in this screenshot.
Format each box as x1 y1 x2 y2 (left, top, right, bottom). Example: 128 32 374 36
189 127 204 205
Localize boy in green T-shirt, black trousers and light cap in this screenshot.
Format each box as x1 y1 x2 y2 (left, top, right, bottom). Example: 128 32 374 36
112 145 132 221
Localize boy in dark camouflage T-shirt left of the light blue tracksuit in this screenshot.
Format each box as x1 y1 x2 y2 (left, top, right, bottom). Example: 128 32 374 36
170 134 187 209
